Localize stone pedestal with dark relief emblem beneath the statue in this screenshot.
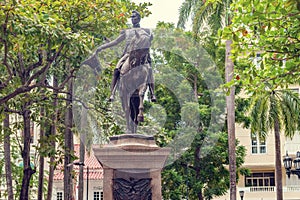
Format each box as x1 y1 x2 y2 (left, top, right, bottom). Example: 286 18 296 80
93 134 170 200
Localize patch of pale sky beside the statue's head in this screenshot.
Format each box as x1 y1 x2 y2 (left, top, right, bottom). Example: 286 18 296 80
132 0 184 28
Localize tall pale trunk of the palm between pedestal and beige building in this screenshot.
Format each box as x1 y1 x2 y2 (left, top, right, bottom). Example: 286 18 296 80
225 40 236 200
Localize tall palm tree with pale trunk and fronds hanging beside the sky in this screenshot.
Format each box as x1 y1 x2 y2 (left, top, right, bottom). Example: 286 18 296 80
178 0 236 200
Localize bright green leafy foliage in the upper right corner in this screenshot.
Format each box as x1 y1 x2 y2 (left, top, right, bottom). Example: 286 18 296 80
228 0 300 92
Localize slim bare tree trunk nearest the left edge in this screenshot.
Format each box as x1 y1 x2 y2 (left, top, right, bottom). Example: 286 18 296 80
3 114 14 200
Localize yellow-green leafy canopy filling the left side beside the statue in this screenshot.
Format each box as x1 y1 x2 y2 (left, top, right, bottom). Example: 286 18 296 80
0 0 150 198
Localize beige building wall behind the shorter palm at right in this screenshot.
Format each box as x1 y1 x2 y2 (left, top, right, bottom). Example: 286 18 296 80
214 119 300 200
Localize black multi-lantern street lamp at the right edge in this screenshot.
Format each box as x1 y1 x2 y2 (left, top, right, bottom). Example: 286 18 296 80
283 151 300 179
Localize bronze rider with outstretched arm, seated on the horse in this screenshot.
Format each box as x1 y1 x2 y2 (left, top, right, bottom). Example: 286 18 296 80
96 11 156 102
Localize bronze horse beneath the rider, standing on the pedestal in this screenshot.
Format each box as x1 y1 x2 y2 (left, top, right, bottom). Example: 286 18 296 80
119 29 151 133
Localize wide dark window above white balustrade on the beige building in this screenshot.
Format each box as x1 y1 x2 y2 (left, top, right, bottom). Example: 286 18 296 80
245 172 275 187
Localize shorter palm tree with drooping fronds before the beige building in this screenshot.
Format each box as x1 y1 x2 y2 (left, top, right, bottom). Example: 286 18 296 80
250 90 300 200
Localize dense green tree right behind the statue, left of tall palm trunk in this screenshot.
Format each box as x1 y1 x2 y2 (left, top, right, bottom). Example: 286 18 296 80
149 23 245 199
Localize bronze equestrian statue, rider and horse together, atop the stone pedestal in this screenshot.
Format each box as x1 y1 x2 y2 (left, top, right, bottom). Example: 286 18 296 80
95 11 156 133
